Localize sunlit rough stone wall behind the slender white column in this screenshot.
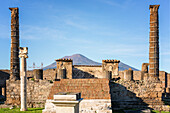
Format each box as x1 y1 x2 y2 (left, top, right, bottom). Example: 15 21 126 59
6 80 53 107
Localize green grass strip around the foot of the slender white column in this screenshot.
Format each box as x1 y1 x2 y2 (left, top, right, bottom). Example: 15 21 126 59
0 108 44 113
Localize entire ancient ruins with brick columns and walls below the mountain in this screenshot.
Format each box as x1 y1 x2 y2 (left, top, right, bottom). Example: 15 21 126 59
0 5 170 113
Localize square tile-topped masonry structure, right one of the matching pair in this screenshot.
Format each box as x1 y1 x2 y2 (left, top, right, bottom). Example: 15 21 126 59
102 60 120 79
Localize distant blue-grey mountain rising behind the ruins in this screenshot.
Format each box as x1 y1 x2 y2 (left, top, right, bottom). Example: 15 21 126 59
43 54 138 71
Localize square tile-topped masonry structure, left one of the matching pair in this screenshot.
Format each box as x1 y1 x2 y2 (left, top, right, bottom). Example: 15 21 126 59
56 59 73 79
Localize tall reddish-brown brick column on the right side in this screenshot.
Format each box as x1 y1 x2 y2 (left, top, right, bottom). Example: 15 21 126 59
149 5 160 79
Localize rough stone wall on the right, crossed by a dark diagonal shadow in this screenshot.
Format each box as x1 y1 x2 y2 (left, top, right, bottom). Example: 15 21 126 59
110 80 168 110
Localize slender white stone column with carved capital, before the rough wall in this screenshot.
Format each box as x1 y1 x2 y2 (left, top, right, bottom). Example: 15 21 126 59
19 47 28 111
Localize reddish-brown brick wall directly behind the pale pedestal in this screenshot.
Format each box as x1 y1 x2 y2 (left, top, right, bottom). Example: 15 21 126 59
48 79 110 99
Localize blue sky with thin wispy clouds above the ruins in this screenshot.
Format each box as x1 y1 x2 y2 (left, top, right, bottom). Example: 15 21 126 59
0 0 170 72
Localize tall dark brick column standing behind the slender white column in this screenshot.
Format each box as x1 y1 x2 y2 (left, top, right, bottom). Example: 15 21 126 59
9 8 20 80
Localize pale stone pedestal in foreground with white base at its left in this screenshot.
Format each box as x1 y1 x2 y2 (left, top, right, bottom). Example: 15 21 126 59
43 93 82 113
